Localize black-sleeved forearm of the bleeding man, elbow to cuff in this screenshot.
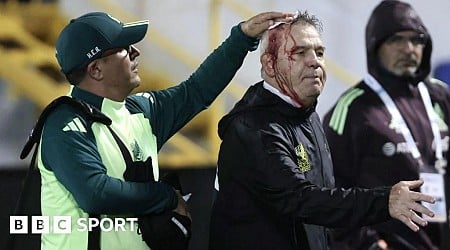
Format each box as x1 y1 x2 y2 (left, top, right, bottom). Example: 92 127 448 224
247 176 390 228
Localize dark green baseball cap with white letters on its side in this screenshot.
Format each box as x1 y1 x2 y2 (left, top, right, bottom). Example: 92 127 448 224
56 12 148 73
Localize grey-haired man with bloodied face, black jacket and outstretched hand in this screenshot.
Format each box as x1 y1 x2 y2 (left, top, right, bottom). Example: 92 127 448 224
209 11 433 250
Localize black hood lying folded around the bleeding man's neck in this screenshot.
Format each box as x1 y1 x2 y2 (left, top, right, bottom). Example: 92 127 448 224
219 81 317 138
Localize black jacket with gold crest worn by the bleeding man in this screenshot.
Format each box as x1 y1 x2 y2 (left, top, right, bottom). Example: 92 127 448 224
210 83 390 250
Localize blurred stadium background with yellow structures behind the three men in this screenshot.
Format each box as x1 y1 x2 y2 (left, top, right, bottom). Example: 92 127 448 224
0 0 450 250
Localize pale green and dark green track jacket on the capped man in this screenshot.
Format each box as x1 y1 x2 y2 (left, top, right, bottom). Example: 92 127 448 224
37 25 258 250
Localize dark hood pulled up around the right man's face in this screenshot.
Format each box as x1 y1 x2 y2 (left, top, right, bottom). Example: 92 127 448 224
366 0 432 85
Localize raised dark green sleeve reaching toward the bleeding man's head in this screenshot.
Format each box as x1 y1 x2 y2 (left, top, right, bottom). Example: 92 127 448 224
150 26 258 146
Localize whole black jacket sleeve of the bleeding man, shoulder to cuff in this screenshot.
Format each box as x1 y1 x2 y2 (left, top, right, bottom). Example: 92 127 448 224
221 120 390 227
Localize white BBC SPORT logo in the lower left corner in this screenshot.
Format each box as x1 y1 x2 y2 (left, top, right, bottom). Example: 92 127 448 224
9 216 138 234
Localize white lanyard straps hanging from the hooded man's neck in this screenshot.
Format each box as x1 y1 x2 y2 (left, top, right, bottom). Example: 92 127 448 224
364 75 446 174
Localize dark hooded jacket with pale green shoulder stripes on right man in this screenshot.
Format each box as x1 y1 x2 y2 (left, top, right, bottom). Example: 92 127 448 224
323 0 450 249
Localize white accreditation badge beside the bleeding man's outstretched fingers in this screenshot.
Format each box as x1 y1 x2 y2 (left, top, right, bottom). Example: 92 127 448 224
420 173 447 222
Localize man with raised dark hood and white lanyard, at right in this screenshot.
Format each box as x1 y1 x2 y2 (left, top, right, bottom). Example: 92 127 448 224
323 0 450 249
